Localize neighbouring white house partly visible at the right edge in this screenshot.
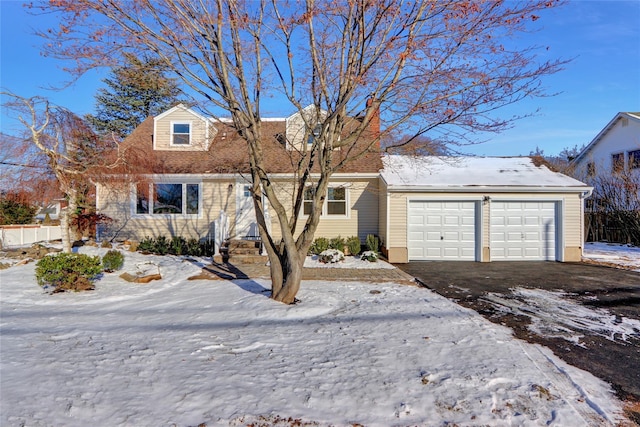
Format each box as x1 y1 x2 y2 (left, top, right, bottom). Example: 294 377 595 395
571 112 640 180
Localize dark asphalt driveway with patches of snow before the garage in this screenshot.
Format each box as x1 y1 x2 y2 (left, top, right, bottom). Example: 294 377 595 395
397 261 640 408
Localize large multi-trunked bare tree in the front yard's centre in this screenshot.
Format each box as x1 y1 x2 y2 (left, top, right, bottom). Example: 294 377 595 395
36 0 562 303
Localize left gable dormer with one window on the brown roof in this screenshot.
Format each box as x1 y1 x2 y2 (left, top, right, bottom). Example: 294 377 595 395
153 104 218 151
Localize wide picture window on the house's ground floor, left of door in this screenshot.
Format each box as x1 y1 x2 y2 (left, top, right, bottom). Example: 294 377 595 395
136 184 201 215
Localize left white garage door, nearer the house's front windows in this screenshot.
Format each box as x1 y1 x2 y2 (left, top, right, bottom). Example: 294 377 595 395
408 200 476 261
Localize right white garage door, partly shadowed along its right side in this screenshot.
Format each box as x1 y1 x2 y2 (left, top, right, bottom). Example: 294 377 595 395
491 201 556 261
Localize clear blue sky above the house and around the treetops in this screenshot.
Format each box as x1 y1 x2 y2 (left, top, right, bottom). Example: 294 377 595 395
0 0 640 156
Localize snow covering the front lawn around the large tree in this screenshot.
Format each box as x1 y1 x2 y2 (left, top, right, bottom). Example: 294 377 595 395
0 248 621 427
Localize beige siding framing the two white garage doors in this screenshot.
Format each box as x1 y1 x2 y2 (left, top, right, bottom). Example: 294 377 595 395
380 192 583 263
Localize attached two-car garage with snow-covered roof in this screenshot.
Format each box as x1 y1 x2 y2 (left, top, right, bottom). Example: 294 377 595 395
379 156 592 263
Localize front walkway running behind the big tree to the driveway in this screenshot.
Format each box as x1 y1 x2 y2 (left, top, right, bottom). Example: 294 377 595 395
191 263 415 284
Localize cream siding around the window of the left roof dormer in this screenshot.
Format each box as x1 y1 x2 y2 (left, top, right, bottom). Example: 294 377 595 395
153 108 215 151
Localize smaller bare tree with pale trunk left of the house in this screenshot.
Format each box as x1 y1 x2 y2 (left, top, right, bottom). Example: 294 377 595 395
2 92 120 252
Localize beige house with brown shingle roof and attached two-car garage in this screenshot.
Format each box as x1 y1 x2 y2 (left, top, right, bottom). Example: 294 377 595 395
96 105 590 263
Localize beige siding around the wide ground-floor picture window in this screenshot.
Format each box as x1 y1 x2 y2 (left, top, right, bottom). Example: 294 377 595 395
97 180 235 244
